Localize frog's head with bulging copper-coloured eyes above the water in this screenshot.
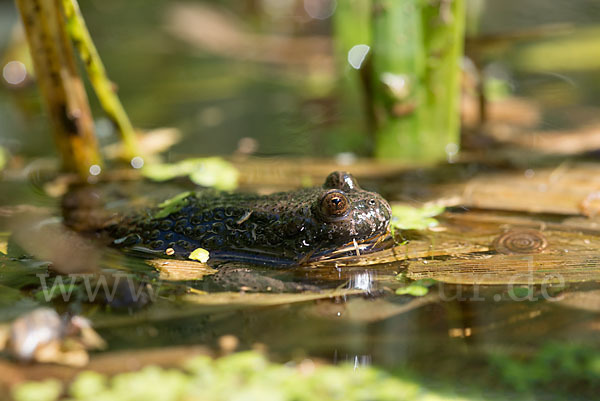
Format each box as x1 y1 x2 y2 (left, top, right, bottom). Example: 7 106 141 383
304 171 391 256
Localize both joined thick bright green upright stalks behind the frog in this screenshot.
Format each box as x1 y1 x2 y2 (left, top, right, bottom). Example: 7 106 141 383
373 0 465 162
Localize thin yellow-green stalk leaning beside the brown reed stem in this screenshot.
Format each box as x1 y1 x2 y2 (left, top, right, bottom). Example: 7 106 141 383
62 0 140 160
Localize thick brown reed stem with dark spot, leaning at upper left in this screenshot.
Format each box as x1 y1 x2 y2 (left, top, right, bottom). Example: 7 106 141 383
16 0 102 177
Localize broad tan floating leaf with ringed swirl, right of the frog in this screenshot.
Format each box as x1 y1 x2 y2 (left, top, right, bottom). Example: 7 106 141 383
408 213 600 284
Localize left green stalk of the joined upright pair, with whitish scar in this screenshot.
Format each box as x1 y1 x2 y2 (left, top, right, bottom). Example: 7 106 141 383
372 0 429 159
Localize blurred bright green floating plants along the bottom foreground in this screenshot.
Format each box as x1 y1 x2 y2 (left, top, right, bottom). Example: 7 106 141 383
13 351 482 401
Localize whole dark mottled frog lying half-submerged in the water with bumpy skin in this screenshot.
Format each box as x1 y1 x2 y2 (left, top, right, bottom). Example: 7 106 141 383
110 172 391 265
